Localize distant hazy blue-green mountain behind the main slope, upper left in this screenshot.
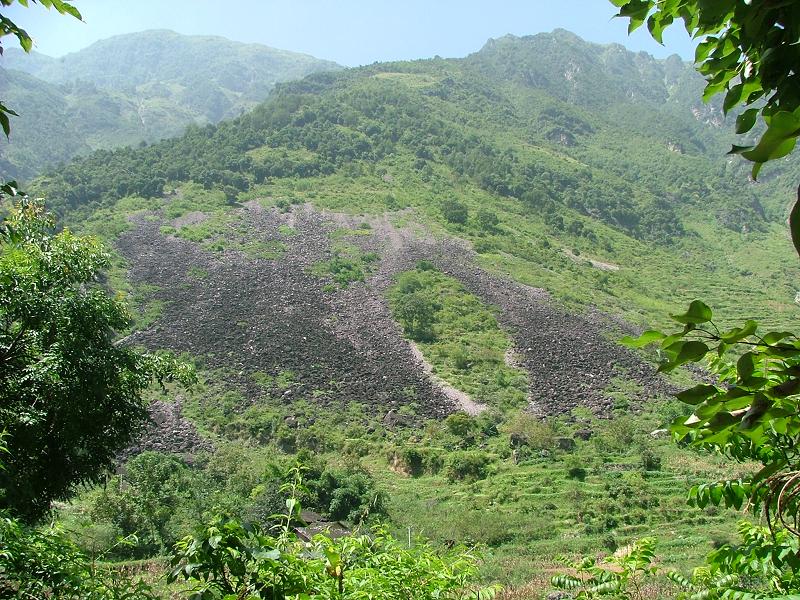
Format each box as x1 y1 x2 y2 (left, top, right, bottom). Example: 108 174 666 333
0 30 341 178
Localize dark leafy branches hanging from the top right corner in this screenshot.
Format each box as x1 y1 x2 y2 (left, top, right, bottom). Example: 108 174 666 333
611 0 800 254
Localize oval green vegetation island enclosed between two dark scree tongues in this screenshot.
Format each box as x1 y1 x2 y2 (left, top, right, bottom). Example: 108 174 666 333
389 261 528 410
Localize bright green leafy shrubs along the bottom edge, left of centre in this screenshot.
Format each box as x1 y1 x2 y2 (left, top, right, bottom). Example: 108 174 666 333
170 512 496 600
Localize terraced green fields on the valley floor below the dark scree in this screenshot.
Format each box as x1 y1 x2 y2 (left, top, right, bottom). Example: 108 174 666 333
372 410 752 585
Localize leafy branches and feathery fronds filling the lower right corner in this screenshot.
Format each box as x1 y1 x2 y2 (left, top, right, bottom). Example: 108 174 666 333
552 300 800 600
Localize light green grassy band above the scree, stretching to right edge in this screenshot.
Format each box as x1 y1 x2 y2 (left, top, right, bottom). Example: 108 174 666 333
242 145 800 328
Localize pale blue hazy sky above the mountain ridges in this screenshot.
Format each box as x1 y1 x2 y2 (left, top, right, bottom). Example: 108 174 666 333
3 0 694 66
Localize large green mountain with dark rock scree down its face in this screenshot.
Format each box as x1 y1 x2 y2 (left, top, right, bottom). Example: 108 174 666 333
29 31 800 584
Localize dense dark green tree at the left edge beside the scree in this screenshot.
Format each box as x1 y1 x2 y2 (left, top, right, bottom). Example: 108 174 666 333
0 190 192 522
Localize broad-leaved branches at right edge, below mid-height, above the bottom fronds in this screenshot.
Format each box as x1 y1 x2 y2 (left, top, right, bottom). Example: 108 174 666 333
625 300 800 535
